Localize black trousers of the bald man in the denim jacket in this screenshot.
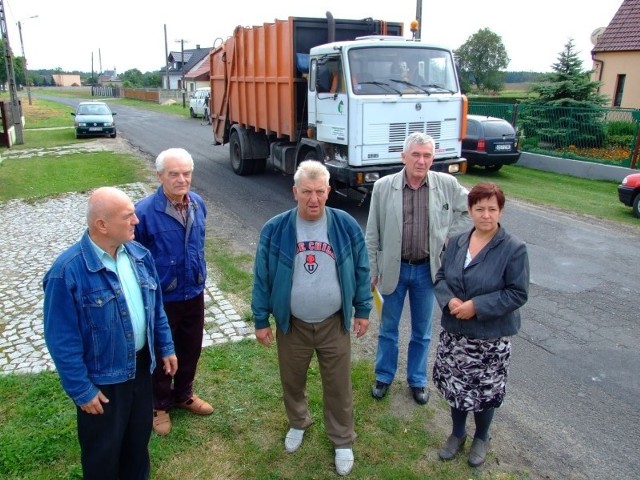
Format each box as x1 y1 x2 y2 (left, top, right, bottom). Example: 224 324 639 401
77 347 153 480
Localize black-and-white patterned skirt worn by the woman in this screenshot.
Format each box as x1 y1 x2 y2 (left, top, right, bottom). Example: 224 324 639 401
433 330 511 412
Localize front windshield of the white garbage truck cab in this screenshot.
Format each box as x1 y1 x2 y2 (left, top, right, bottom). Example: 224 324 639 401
349 46 459 95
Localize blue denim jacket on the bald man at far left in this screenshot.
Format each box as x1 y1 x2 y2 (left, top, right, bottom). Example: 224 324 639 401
43 231 175 405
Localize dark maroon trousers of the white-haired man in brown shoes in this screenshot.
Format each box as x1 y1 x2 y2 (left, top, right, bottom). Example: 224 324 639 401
153 292 204 410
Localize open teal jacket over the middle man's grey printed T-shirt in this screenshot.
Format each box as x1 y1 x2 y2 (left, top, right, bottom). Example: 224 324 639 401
251 207 372 333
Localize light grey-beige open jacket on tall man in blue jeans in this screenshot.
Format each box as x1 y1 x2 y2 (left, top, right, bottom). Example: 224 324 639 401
366 169 471 295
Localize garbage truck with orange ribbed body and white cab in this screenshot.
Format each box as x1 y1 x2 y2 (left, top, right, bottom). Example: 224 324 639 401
210 12 468 199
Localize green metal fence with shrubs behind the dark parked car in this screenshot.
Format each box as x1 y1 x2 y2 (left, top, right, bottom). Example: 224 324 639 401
469 102 640 168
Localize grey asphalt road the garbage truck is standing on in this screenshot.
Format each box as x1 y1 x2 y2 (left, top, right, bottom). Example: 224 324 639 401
52 99 640 479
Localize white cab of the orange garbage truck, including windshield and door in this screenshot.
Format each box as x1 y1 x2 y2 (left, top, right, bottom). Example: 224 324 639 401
307 36 467 189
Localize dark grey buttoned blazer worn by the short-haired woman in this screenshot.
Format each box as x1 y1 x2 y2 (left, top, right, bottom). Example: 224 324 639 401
435 227 529 339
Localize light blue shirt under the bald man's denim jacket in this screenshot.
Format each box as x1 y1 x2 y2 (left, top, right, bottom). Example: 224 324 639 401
91 240 147 351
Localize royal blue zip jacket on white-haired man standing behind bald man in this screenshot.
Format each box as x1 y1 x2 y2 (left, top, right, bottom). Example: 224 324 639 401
135 186 207 302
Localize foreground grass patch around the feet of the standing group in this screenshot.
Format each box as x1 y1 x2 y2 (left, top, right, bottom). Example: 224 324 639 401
0 341 526 480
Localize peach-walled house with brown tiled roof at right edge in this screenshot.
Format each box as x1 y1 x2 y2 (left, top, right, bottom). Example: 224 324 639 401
591 0 640 108
